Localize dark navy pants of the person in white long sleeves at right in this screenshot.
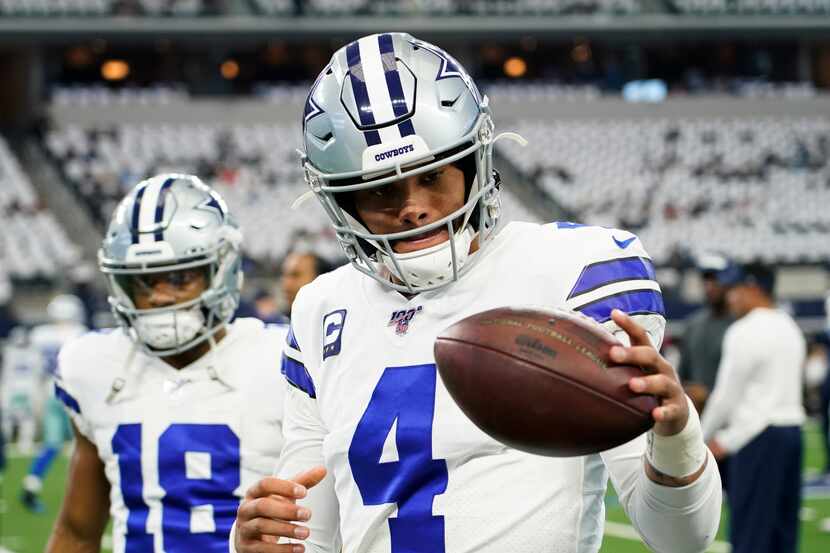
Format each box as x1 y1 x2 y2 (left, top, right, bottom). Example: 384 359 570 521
728 426 802 553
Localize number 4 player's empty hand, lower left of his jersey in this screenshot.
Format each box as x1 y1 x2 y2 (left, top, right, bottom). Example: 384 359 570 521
234 467 326 553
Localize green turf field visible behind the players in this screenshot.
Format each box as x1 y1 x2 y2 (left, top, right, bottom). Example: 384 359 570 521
0 426 830 553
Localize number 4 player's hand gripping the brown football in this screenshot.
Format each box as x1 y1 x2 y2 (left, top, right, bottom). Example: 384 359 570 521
609 309 689 436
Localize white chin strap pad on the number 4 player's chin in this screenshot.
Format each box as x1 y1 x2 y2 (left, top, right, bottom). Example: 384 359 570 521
380 226 475 288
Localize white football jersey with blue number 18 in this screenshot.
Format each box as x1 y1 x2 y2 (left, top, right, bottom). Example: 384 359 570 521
56 319 288 553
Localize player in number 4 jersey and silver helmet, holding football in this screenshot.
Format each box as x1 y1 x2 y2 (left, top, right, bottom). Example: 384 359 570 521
232 33 721 553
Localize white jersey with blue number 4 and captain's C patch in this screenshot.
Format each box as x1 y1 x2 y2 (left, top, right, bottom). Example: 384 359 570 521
278 223 720 553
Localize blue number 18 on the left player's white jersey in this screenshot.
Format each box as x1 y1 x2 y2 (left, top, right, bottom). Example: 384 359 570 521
112 424 240 553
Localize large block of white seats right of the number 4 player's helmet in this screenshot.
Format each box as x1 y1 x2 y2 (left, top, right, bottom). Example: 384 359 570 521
503 117 830 263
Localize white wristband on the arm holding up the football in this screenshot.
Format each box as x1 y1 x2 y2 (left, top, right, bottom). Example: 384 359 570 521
646 396 706 478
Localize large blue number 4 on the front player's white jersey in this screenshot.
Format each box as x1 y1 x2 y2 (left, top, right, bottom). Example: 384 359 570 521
349 364 447 553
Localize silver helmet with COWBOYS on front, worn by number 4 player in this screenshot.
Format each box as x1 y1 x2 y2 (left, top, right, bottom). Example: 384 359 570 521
303 33 499 292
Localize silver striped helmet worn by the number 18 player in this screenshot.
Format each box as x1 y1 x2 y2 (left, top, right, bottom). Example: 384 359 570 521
98 174 242 356
